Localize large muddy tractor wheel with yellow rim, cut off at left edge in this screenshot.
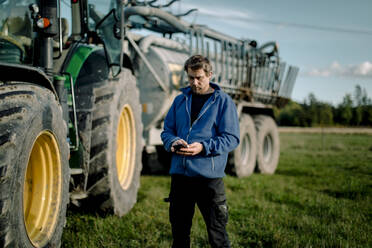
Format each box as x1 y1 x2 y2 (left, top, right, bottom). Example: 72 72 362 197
0 83 69 248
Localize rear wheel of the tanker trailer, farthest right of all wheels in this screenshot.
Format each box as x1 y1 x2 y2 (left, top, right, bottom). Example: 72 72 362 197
254 115 280 174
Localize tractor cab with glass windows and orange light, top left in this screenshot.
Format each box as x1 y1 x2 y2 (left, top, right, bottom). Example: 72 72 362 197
0 0 124 75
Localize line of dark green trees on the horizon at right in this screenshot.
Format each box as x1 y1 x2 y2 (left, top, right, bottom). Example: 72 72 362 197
275 85 372 127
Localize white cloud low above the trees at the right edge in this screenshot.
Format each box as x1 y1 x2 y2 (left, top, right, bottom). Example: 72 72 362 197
303 61 372 78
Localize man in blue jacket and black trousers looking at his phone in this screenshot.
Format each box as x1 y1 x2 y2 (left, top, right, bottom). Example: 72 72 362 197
161 55 240 248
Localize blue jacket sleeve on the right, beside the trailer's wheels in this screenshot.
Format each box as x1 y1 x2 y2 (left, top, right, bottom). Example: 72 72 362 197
201 97 240 156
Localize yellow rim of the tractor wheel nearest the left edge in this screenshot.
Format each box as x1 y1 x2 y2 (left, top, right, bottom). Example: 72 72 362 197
23 131 62 247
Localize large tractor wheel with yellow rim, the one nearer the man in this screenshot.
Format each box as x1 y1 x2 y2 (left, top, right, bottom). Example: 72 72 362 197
80 69 143 216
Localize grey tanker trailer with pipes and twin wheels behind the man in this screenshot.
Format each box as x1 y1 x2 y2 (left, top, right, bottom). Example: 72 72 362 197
124 1 298 177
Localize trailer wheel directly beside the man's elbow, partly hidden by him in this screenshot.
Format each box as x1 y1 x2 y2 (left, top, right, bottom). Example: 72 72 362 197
233 114 257 177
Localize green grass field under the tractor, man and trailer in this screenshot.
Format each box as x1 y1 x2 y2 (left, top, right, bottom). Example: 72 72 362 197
62 133 372 248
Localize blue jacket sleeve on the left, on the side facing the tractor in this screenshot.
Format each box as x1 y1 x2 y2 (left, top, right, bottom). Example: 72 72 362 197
160 101 180 152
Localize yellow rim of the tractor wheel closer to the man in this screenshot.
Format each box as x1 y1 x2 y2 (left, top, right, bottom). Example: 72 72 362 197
116 104 136 190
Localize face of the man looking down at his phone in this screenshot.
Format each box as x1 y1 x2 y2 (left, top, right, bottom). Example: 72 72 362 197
187 68 212 95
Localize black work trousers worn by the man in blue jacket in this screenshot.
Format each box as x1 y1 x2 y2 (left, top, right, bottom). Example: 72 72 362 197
169 175 230 248
